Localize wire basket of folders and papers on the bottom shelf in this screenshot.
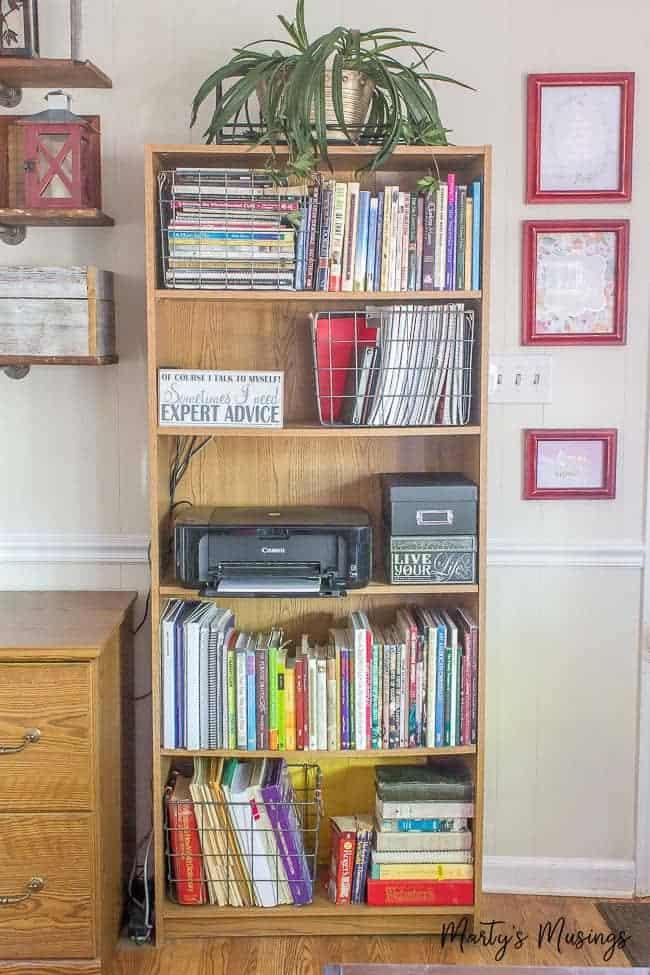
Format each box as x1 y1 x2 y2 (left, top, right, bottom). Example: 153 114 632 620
164 759 322 907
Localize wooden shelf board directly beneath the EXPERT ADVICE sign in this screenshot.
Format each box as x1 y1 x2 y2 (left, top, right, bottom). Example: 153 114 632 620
158 423 481 440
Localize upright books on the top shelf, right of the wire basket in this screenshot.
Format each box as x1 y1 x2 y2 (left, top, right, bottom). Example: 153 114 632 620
295 173 482 291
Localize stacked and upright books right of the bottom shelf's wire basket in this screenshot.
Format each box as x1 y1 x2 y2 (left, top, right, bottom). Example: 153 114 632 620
328 759 474 907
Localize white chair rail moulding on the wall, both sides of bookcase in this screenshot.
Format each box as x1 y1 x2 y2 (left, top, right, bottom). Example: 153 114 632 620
0 532 645 569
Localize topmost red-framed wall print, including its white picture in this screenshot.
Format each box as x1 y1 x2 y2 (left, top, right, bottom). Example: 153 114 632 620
526 72 634 203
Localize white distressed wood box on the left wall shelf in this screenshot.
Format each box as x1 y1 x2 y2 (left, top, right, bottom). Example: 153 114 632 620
0 267 117 365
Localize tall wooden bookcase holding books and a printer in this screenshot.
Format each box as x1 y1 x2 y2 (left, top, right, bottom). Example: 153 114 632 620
145 145 491 943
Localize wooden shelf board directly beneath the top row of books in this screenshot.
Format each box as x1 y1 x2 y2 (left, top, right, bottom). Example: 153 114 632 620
155 288 481 305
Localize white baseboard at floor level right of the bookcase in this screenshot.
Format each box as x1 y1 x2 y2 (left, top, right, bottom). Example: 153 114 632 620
483 856 635 897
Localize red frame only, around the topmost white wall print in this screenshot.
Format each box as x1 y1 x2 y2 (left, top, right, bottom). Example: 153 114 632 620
526 72 634 203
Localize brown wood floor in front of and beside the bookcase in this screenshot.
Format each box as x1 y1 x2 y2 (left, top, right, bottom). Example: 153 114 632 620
111 895 629 975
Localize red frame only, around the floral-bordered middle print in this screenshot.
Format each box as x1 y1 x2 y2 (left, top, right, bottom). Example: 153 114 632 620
521 220 630 345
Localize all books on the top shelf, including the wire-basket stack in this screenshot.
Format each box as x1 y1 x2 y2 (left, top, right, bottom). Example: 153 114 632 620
160 167 483 292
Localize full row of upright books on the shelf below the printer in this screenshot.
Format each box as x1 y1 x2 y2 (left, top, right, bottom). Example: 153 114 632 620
160 600 478 751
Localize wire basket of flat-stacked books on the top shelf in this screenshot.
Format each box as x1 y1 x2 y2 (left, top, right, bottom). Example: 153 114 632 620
158 167 306 291
